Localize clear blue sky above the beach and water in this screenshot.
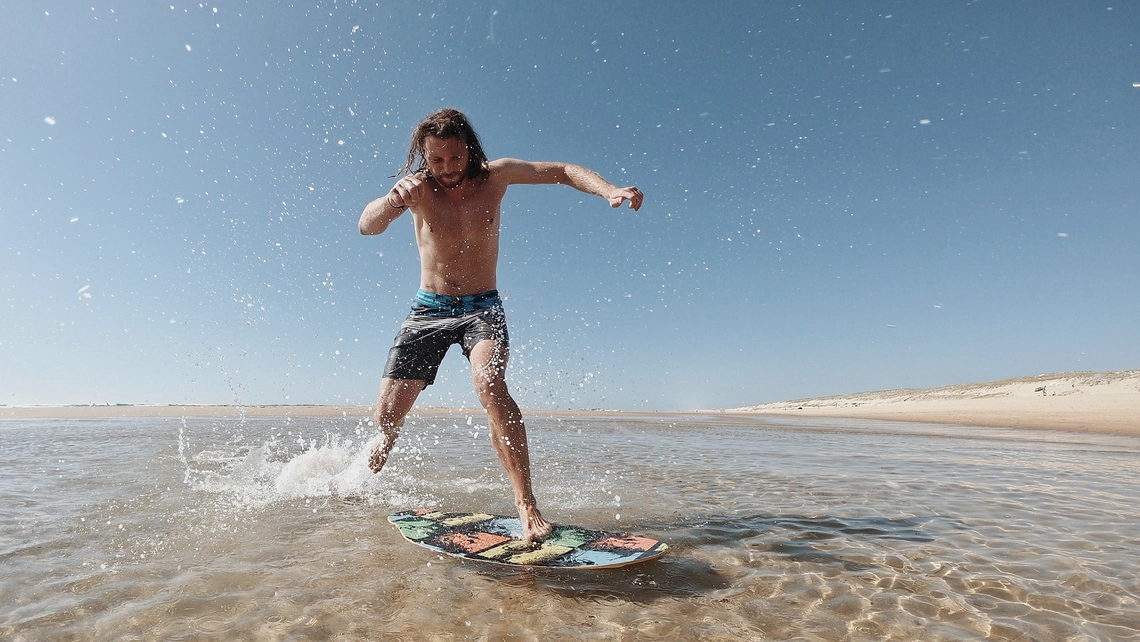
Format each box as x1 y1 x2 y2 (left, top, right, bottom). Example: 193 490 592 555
0 0 1140 409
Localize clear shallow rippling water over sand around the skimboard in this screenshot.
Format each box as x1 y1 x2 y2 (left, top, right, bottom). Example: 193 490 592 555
0 414 1140 640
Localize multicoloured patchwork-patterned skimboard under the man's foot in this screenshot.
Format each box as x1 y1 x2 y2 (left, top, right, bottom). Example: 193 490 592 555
388 509 669 569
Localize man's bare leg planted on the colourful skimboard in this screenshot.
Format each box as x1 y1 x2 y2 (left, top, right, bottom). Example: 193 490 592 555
470 339 553 539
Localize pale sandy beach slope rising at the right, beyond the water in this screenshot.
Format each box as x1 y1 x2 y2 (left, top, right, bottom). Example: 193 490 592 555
726 371 1140 436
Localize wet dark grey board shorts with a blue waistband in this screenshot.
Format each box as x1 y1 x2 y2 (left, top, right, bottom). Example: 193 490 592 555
384 290 510 388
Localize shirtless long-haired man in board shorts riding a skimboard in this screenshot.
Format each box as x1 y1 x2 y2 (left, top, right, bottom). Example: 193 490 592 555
360 109 643 539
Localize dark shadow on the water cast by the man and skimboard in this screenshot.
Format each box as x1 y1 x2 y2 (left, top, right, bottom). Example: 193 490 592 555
449 514 953 604
